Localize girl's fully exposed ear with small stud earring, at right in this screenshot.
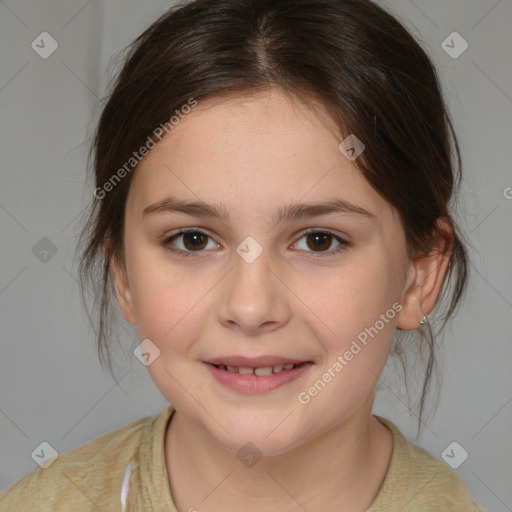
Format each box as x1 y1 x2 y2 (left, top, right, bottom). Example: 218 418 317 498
397 219 453 330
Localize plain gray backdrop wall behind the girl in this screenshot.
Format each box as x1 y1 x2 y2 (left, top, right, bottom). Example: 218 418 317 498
0 0 512 511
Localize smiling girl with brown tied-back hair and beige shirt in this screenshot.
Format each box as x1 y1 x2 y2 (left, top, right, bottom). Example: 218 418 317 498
0 0 486 512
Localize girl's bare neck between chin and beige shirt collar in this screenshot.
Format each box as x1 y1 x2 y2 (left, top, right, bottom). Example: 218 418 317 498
165 403 392 512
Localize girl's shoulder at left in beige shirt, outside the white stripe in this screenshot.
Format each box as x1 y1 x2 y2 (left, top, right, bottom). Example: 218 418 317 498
0 410 171 512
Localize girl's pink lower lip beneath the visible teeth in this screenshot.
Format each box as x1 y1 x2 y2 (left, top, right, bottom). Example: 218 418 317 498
204 363 313 394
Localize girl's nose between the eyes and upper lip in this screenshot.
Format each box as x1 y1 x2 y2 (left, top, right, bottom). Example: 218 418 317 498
217 244 291 335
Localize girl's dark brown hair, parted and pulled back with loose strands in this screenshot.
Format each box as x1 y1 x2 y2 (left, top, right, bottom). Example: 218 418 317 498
79 0 468 430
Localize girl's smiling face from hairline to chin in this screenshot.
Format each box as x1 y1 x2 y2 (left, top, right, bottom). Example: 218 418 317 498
116 90 419 455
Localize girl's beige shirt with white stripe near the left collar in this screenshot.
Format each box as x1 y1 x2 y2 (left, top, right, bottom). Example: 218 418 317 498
0 406 482 512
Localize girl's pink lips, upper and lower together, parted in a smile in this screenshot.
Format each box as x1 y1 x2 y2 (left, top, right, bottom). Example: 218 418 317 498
203 357 313 394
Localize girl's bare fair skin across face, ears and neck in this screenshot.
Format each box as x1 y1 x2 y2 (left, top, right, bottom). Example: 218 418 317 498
112 89 449 512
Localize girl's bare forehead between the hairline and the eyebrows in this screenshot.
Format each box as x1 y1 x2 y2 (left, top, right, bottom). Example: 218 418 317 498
129 90 393 225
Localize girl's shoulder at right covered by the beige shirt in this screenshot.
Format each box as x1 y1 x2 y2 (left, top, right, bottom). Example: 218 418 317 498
368 417 482 512
